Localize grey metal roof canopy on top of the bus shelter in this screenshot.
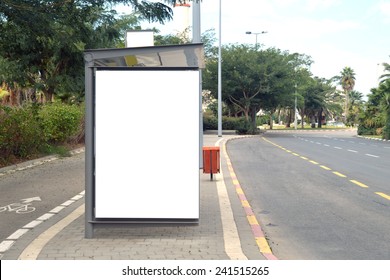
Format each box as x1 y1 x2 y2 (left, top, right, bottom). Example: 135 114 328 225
84 43 205 69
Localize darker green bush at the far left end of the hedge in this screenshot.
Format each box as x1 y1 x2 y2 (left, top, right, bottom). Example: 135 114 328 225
0 105 43 161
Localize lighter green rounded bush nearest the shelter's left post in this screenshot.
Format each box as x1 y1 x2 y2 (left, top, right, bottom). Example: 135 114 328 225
39 103 83 143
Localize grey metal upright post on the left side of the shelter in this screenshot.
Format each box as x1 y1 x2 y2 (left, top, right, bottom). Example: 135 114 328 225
84 54 94 238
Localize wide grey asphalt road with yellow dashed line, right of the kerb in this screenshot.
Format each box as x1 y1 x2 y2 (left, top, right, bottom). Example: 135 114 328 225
227 132 390 260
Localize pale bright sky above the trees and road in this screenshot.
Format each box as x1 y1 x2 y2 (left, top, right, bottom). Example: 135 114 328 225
118 0 390 95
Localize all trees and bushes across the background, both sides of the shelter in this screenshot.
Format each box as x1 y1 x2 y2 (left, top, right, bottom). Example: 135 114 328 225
0 0 390 166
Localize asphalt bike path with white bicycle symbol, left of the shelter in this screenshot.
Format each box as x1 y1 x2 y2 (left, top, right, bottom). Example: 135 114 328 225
0 153 85 242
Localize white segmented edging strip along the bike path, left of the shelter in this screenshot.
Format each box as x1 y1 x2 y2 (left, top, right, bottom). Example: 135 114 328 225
0 191 85 259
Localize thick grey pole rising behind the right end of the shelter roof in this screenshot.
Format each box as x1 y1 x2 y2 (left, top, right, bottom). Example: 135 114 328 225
192 1 203 166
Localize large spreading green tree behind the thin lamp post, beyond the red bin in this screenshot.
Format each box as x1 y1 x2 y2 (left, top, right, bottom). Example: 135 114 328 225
203 45 310 132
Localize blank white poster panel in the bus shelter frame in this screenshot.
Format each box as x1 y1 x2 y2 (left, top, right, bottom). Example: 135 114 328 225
95 69 199 219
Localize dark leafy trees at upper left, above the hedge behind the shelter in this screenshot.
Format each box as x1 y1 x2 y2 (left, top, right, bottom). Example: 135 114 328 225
0 0 189 101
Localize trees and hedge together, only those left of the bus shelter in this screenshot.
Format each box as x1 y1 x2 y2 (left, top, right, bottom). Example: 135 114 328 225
0 0 186 167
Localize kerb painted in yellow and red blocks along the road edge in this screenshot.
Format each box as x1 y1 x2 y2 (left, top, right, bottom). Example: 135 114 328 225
223 139 278 260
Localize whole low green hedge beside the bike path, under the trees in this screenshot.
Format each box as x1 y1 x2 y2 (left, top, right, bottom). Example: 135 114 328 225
0 104 84 166
